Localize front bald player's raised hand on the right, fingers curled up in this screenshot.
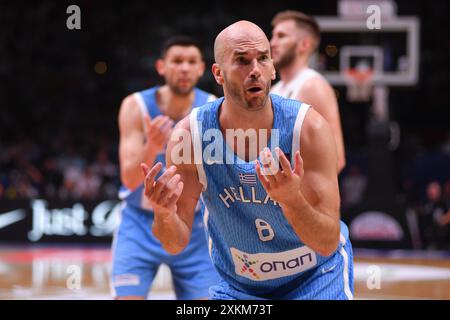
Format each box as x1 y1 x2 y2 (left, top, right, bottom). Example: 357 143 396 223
255 148 304 205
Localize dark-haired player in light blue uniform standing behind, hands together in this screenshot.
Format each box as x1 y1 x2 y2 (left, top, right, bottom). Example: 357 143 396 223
111 37 219 299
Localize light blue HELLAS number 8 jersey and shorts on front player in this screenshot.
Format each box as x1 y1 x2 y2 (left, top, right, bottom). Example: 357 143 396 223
190 95 353 299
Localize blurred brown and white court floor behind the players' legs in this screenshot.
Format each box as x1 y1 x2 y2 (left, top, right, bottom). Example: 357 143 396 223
0 246 450 300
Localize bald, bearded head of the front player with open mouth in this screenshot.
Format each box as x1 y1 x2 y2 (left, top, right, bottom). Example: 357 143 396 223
212 21 275 111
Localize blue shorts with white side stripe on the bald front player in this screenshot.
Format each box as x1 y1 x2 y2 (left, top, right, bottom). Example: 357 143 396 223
209 240 354 300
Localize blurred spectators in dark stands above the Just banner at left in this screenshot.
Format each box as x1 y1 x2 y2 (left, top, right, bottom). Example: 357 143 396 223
0 132 119 200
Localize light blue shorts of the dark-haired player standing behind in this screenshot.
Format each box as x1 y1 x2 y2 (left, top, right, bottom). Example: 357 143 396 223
111 205 220 300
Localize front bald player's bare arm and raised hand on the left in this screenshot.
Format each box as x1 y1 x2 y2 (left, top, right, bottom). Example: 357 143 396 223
143 117 202 254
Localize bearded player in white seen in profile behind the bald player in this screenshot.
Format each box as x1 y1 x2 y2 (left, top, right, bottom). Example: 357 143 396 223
270 10 345 172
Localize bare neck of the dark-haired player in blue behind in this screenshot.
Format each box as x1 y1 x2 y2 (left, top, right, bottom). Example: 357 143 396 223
156 85 195 120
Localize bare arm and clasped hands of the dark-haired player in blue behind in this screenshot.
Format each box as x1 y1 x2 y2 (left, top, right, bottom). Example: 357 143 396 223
119 95 173 190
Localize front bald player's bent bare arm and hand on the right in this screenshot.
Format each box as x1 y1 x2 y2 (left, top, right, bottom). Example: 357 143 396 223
255 109 340 256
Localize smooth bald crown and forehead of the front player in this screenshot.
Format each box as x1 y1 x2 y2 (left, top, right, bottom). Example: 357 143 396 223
214 20 270 64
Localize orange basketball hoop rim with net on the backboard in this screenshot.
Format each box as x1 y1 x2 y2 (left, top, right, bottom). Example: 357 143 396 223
344 68 374 102
